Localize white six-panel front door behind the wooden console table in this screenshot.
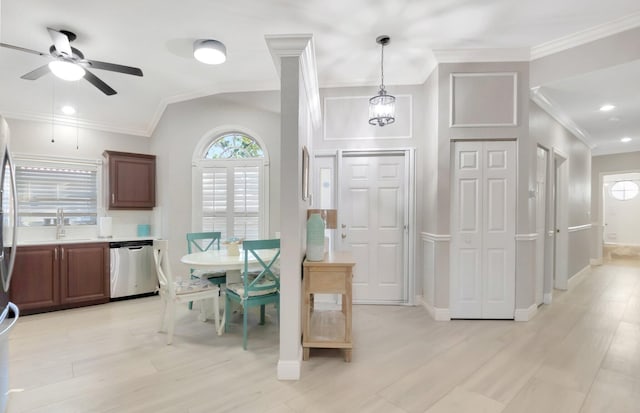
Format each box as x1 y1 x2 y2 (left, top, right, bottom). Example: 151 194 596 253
337 152 408 304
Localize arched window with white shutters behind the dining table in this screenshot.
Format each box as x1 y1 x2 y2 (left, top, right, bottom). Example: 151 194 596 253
200 132 268 241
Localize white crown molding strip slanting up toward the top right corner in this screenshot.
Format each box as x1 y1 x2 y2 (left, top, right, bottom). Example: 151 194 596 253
531 13 640 60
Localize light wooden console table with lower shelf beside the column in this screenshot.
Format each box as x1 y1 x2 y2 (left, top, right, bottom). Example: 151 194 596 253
302 251 355 362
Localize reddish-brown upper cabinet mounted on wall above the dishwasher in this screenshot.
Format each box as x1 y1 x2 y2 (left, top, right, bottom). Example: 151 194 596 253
104 151 156 209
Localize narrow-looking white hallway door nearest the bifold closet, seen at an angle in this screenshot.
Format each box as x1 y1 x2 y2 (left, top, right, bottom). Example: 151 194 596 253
535 147 548 305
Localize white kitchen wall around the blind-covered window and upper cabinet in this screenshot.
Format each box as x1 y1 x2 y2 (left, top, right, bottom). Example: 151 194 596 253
7 119 153 241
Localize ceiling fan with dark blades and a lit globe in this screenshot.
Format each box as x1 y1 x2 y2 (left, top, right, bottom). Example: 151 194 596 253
0 27 142 96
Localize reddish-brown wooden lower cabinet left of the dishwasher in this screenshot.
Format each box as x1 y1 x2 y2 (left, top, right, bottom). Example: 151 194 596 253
9 242 110 314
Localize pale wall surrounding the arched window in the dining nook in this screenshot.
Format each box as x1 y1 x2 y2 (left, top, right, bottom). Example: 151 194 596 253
151 92 280 273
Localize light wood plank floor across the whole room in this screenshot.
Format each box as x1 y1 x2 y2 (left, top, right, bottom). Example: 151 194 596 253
8 262 640 413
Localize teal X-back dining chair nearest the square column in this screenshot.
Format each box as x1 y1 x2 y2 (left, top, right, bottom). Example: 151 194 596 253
224 239 280 350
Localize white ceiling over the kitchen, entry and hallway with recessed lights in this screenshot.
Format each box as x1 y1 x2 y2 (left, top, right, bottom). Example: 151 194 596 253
0 0 640 151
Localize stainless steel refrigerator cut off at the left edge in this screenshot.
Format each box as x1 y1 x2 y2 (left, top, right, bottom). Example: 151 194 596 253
0 115 19 412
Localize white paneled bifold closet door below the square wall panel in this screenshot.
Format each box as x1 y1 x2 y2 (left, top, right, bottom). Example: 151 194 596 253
450 141 516 319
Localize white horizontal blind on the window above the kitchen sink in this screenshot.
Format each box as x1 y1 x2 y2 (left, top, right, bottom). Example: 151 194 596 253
16 163 98 226
